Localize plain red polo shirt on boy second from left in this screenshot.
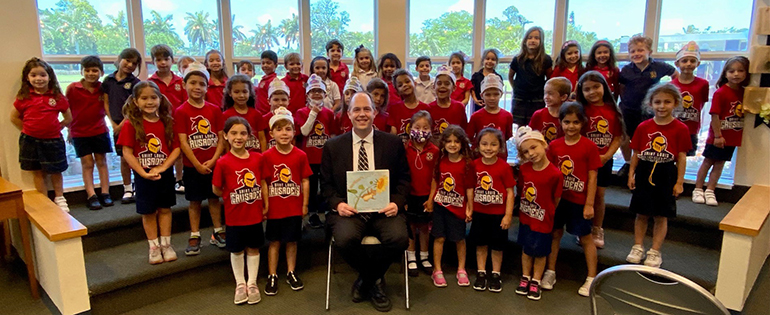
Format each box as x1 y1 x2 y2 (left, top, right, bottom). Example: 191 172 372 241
66 81 109 138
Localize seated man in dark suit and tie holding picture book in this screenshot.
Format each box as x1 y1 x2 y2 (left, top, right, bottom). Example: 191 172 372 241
321 92 410 312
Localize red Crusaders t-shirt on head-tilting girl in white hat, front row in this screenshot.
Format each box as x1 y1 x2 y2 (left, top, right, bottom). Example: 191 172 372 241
519 163 562 233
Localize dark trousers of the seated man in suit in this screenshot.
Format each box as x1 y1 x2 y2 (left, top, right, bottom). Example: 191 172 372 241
326 212 409 289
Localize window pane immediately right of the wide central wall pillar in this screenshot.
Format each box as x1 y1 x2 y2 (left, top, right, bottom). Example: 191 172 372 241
409 0 474 57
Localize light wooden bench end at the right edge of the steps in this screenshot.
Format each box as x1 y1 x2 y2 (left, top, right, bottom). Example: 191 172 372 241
716 185 770 311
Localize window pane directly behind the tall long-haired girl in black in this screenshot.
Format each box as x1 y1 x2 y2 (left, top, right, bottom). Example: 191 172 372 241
484 0 556 56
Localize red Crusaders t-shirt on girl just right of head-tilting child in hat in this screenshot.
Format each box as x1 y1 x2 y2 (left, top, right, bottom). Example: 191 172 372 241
548 137 602 205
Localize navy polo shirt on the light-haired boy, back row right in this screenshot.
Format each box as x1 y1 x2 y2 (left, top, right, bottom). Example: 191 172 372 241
618 58 676 113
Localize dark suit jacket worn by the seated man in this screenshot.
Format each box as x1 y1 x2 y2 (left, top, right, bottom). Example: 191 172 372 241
321 130 411 211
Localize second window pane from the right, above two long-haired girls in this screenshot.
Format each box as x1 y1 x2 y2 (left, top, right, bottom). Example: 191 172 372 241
567 0 644 54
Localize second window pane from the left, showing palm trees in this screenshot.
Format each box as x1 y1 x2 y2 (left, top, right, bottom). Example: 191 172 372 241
142 0 219 57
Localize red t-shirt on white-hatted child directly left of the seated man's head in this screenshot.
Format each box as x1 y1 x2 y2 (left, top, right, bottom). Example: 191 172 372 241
294 107 337 164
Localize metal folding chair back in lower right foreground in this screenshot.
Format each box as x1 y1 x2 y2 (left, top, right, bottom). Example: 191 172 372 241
590 265 730 315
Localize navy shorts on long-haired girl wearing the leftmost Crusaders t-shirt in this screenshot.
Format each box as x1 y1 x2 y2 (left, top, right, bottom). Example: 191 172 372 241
134 168 176 214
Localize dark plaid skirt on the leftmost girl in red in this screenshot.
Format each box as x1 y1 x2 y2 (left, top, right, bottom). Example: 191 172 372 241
19 133 69 174
